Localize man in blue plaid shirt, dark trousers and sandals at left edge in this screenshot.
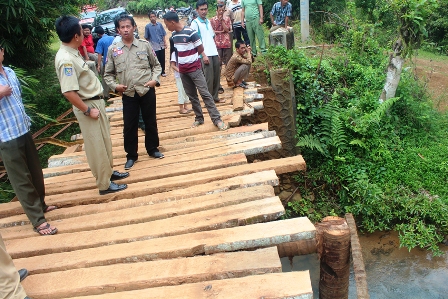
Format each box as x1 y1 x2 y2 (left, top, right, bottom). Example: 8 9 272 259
0 44 58 237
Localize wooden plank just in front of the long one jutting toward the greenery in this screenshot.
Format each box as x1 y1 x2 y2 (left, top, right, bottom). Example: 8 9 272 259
0 170 278 229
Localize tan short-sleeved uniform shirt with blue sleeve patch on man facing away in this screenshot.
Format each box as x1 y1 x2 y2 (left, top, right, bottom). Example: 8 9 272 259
54 45 103 100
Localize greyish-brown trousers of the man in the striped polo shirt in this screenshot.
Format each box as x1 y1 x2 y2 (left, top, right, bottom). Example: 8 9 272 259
180 69 221 125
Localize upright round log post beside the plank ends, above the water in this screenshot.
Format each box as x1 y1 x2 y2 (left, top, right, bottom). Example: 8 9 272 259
316 217 350 299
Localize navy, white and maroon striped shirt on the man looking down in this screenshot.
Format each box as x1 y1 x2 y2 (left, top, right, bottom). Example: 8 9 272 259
172 27 202 74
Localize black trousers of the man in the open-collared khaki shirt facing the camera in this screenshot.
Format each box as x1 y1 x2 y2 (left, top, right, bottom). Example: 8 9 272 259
123 88 159 160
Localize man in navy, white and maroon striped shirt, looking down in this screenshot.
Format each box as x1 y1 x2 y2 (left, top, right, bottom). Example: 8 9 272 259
163 12 227 130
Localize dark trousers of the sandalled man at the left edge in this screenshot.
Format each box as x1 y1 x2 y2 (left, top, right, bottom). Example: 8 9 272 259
0 133 48 227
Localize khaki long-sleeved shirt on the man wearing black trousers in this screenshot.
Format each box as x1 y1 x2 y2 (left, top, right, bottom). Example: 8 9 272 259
104 38 162 97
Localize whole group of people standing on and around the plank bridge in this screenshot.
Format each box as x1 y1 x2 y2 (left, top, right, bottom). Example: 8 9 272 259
0 0 291 299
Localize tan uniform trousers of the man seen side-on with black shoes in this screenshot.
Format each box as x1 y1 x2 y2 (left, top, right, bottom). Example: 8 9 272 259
73 99 114 190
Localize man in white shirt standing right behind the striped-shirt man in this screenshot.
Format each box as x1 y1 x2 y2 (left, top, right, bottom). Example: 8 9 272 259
190 0 225 103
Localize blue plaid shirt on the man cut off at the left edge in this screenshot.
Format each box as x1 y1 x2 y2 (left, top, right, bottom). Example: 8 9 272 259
0 67 31 142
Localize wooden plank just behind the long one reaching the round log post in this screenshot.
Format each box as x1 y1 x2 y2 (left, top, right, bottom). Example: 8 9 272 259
5 197 284 258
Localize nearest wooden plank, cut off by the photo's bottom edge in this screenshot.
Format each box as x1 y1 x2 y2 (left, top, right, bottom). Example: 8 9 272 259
65 271 313 299
